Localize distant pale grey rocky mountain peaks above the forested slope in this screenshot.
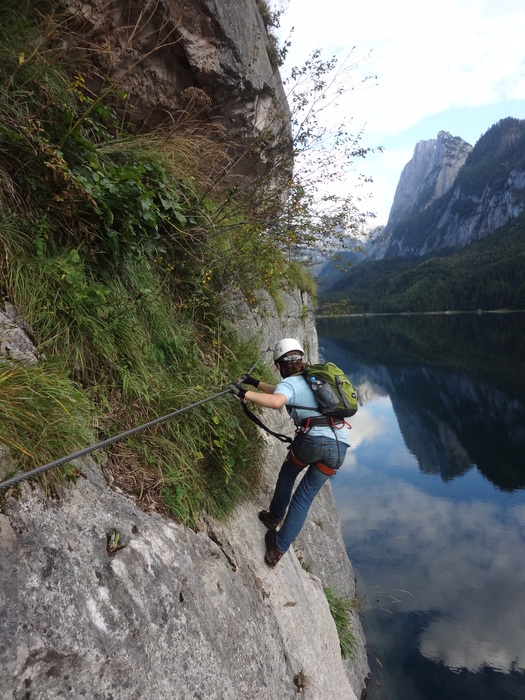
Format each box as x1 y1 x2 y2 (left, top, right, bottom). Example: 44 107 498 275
369 117 525 259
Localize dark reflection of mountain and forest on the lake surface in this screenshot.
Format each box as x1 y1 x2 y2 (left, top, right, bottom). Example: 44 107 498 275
319 315 525 490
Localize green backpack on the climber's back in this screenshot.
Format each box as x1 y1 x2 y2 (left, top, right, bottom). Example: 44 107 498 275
289 362 358 418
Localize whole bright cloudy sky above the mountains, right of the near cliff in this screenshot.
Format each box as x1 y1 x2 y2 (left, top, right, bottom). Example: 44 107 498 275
273 0 525 225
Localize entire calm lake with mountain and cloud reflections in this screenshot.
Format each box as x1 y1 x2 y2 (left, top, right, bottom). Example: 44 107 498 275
318 314 525 700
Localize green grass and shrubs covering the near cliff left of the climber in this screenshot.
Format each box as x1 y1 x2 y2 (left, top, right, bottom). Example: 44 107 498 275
0 2 305 525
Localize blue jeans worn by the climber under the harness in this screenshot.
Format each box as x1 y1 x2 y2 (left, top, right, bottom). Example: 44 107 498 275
270 433 348 554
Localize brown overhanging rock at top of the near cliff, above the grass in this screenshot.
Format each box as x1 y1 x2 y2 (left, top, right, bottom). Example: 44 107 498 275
64 0 291 176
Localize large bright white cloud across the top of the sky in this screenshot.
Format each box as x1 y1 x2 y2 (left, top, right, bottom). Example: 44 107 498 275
283 0 525 129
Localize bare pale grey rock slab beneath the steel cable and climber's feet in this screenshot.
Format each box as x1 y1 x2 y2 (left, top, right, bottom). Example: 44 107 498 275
0 298 368 700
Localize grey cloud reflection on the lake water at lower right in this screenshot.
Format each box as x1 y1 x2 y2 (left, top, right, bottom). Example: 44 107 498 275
336 476 525 672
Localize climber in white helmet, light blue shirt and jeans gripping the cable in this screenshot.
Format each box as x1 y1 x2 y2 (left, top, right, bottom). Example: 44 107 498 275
228 338 350 567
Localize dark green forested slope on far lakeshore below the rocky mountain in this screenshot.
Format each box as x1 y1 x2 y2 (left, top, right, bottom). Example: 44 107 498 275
320 215 525 313
